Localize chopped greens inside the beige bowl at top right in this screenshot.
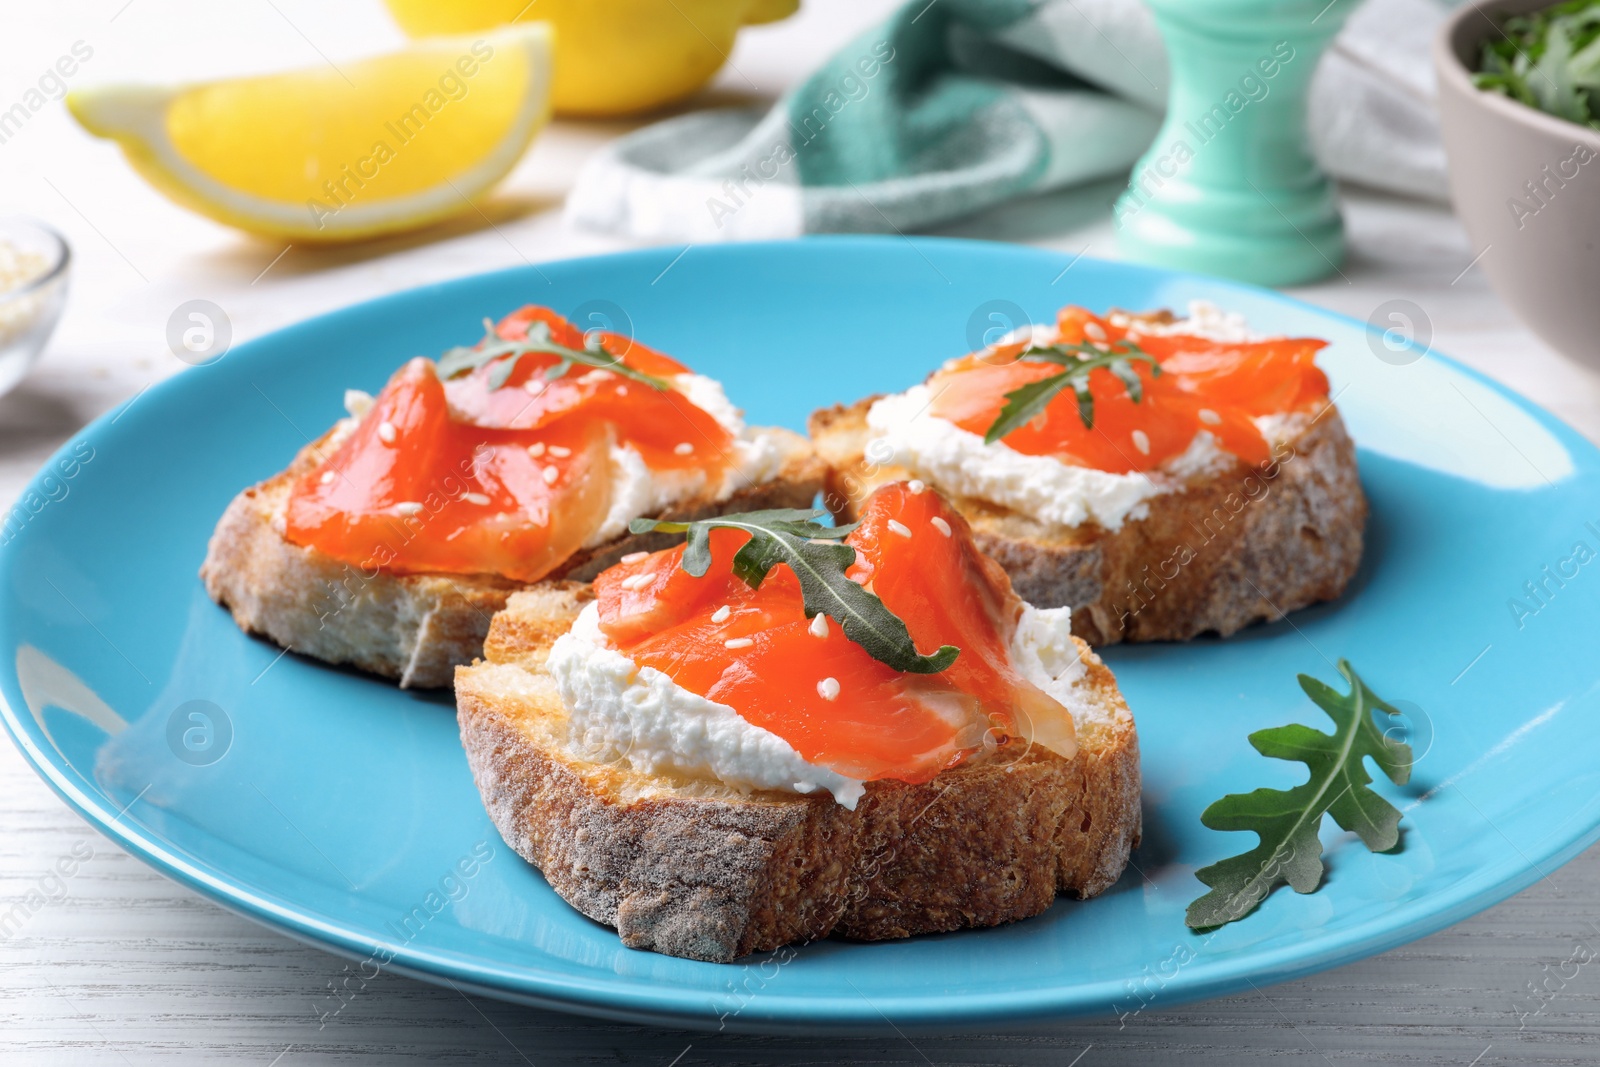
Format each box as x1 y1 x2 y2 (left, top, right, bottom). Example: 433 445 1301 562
1472 0 1600 130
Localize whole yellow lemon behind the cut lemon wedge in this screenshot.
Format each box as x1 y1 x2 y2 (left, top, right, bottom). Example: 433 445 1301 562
387 0 800 115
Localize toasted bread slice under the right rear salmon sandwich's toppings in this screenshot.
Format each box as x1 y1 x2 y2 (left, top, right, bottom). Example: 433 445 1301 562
811 397 1366 645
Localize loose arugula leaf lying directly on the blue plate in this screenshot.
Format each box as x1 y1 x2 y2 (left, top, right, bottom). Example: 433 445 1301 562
1184 659 1411 929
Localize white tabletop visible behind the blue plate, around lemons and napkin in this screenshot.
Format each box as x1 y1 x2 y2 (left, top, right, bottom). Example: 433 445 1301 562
0 0 1600 494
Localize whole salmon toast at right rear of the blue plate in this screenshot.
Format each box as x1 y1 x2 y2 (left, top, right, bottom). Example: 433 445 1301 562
811 304 1366 645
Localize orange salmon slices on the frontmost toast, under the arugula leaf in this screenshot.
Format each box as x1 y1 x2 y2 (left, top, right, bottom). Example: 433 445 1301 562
595 483 1075 782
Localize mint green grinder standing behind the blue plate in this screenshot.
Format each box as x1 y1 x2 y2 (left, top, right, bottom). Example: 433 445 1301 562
1115 0 1355 285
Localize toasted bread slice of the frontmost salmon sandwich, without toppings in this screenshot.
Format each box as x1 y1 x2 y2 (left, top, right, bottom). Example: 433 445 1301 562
456 582 1141 961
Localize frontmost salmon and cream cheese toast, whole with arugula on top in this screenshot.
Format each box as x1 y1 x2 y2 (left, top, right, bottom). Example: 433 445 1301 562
456 483 1141 961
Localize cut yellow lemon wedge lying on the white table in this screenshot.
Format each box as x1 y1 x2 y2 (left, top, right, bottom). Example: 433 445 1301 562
67 22 550 242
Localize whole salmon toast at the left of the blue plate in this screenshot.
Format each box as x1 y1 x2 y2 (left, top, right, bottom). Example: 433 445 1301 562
200 307 822 686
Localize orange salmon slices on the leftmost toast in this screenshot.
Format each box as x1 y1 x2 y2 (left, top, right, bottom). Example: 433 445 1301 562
285 307 731 581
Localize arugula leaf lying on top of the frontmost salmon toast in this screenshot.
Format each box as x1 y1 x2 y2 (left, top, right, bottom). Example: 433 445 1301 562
629 509 962 673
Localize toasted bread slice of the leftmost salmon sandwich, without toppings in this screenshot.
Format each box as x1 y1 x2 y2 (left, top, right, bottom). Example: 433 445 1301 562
200 429 824 688
